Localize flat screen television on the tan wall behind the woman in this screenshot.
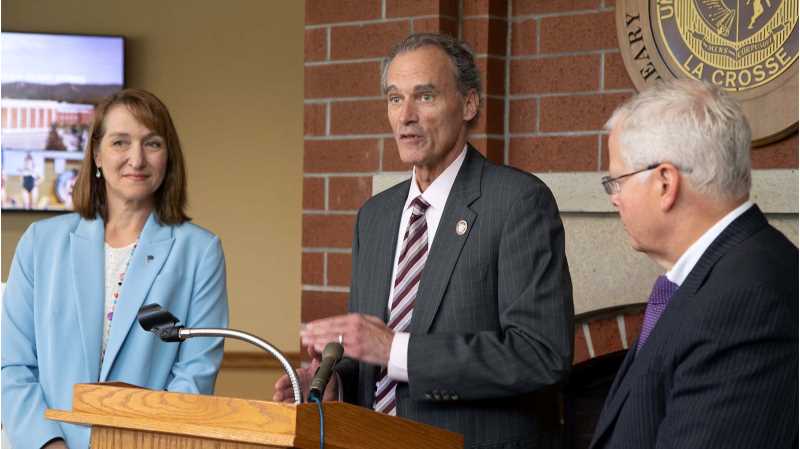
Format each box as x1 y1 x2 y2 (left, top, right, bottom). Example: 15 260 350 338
0 32 125 211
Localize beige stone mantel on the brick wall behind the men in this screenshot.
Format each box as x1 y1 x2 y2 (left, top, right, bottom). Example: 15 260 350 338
373 170 798 314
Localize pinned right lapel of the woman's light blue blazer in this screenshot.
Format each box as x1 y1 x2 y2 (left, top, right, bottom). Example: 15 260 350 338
100 214 175 382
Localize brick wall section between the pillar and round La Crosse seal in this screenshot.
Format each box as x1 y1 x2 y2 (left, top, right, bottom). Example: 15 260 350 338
508 0 634 172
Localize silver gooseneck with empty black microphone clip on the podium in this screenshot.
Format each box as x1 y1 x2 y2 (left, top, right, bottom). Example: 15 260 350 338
136 304 304 404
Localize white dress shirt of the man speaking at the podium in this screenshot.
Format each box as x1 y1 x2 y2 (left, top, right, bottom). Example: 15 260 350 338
387 145 467 382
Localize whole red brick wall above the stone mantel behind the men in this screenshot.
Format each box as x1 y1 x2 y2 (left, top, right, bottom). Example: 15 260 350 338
302 0 798 326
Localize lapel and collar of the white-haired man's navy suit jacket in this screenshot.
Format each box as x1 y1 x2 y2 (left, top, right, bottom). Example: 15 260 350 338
589 206 767 447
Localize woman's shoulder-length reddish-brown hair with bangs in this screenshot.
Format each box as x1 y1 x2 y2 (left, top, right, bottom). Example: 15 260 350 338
72 89 190 225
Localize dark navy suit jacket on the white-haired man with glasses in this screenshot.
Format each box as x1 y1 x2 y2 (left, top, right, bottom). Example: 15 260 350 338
590 206 798 449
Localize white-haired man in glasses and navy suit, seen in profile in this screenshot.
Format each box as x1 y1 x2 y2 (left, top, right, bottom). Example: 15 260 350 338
591 80 798 449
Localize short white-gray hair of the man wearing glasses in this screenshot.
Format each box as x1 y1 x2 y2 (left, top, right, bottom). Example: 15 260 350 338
605 79 751 200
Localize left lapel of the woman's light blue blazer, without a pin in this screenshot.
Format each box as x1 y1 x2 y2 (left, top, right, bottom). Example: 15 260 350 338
69 218 105 379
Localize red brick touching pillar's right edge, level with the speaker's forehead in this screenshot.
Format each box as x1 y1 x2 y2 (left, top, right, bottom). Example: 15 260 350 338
511 55 600 94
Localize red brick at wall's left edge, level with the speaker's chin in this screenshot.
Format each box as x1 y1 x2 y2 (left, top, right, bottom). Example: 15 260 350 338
303 139 378 173
